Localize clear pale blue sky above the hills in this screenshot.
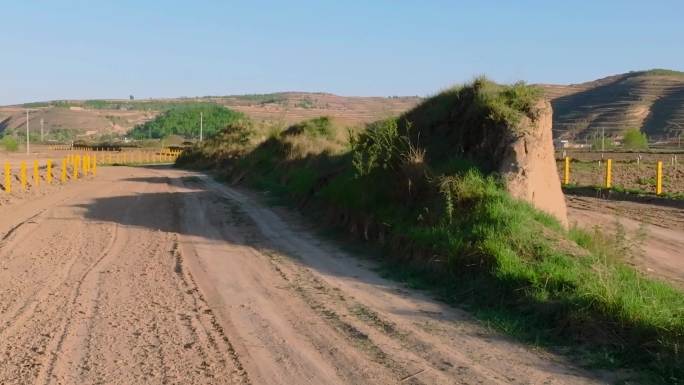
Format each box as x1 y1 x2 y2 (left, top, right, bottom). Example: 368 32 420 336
0 0 684 105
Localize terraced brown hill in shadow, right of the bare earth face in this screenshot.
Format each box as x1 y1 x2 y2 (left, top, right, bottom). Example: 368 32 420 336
540 69 684 139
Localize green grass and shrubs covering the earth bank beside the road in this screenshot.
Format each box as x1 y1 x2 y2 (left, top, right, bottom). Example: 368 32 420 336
178 79 684 383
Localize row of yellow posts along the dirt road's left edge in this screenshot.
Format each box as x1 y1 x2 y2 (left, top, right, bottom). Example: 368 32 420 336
4 154 98 193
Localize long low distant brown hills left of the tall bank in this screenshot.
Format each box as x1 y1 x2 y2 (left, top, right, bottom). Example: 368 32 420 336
0 92 421 139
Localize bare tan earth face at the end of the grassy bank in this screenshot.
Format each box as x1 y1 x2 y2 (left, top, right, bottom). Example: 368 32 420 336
498 100 568 227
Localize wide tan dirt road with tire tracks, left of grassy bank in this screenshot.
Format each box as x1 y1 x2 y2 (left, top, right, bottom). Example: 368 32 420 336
0 167 602 385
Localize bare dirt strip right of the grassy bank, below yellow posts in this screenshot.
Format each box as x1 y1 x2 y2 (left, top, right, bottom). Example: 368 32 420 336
566 195 684 288
